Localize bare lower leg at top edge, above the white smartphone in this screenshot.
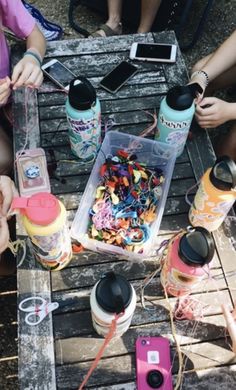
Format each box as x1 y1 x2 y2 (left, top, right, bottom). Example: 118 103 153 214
137 0 162 33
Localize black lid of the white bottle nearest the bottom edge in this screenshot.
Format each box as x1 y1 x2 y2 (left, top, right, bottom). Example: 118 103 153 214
96 272 132 314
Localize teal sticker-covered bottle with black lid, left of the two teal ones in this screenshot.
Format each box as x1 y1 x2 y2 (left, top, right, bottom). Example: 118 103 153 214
66 77 101 160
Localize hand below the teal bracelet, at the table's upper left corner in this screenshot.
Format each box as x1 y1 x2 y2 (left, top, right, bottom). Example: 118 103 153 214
11 56 43 89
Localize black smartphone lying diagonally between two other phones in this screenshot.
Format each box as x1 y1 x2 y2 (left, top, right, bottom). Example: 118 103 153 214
100 61 138 93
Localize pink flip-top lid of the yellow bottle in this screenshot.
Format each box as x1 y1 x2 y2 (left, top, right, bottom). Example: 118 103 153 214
11 192 60 226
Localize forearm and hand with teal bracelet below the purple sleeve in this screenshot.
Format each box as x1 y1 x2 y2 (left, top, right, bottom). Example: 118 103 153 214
11 25 46 89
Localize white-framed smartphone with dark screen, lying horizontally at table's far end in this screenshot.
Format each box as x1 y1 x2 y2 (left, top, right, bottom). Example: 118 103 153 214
130 42 177 63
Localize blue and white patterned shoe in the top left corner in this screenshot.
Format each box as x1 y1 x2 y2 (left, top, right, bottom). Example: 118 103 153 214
22 0 63 41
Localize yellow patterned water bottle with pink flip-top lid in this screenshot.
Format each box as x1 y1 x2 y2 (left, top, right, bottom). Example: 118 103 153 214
11 192 72 271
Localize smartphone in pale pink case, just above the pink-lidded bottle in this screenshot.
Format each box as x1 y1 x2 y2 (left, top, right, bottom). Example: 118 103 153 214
16 148 51 197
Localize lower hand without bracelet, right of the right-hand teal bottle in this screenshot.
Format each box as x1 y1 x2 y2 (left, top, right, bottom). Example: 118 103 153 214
195 97 232 128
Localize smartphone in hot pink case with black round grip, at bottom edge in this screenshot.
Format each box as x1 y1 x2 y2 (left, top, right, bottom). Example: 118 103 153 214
136 337 173 390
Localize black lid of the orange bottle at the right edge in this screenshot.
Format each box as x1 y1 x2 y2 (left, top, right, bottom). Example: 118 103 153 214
210 156 236 191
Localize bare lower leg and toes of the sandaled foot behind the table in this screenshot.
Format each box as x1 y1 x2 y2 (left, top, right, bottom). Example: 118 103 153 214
92 0 122 37
